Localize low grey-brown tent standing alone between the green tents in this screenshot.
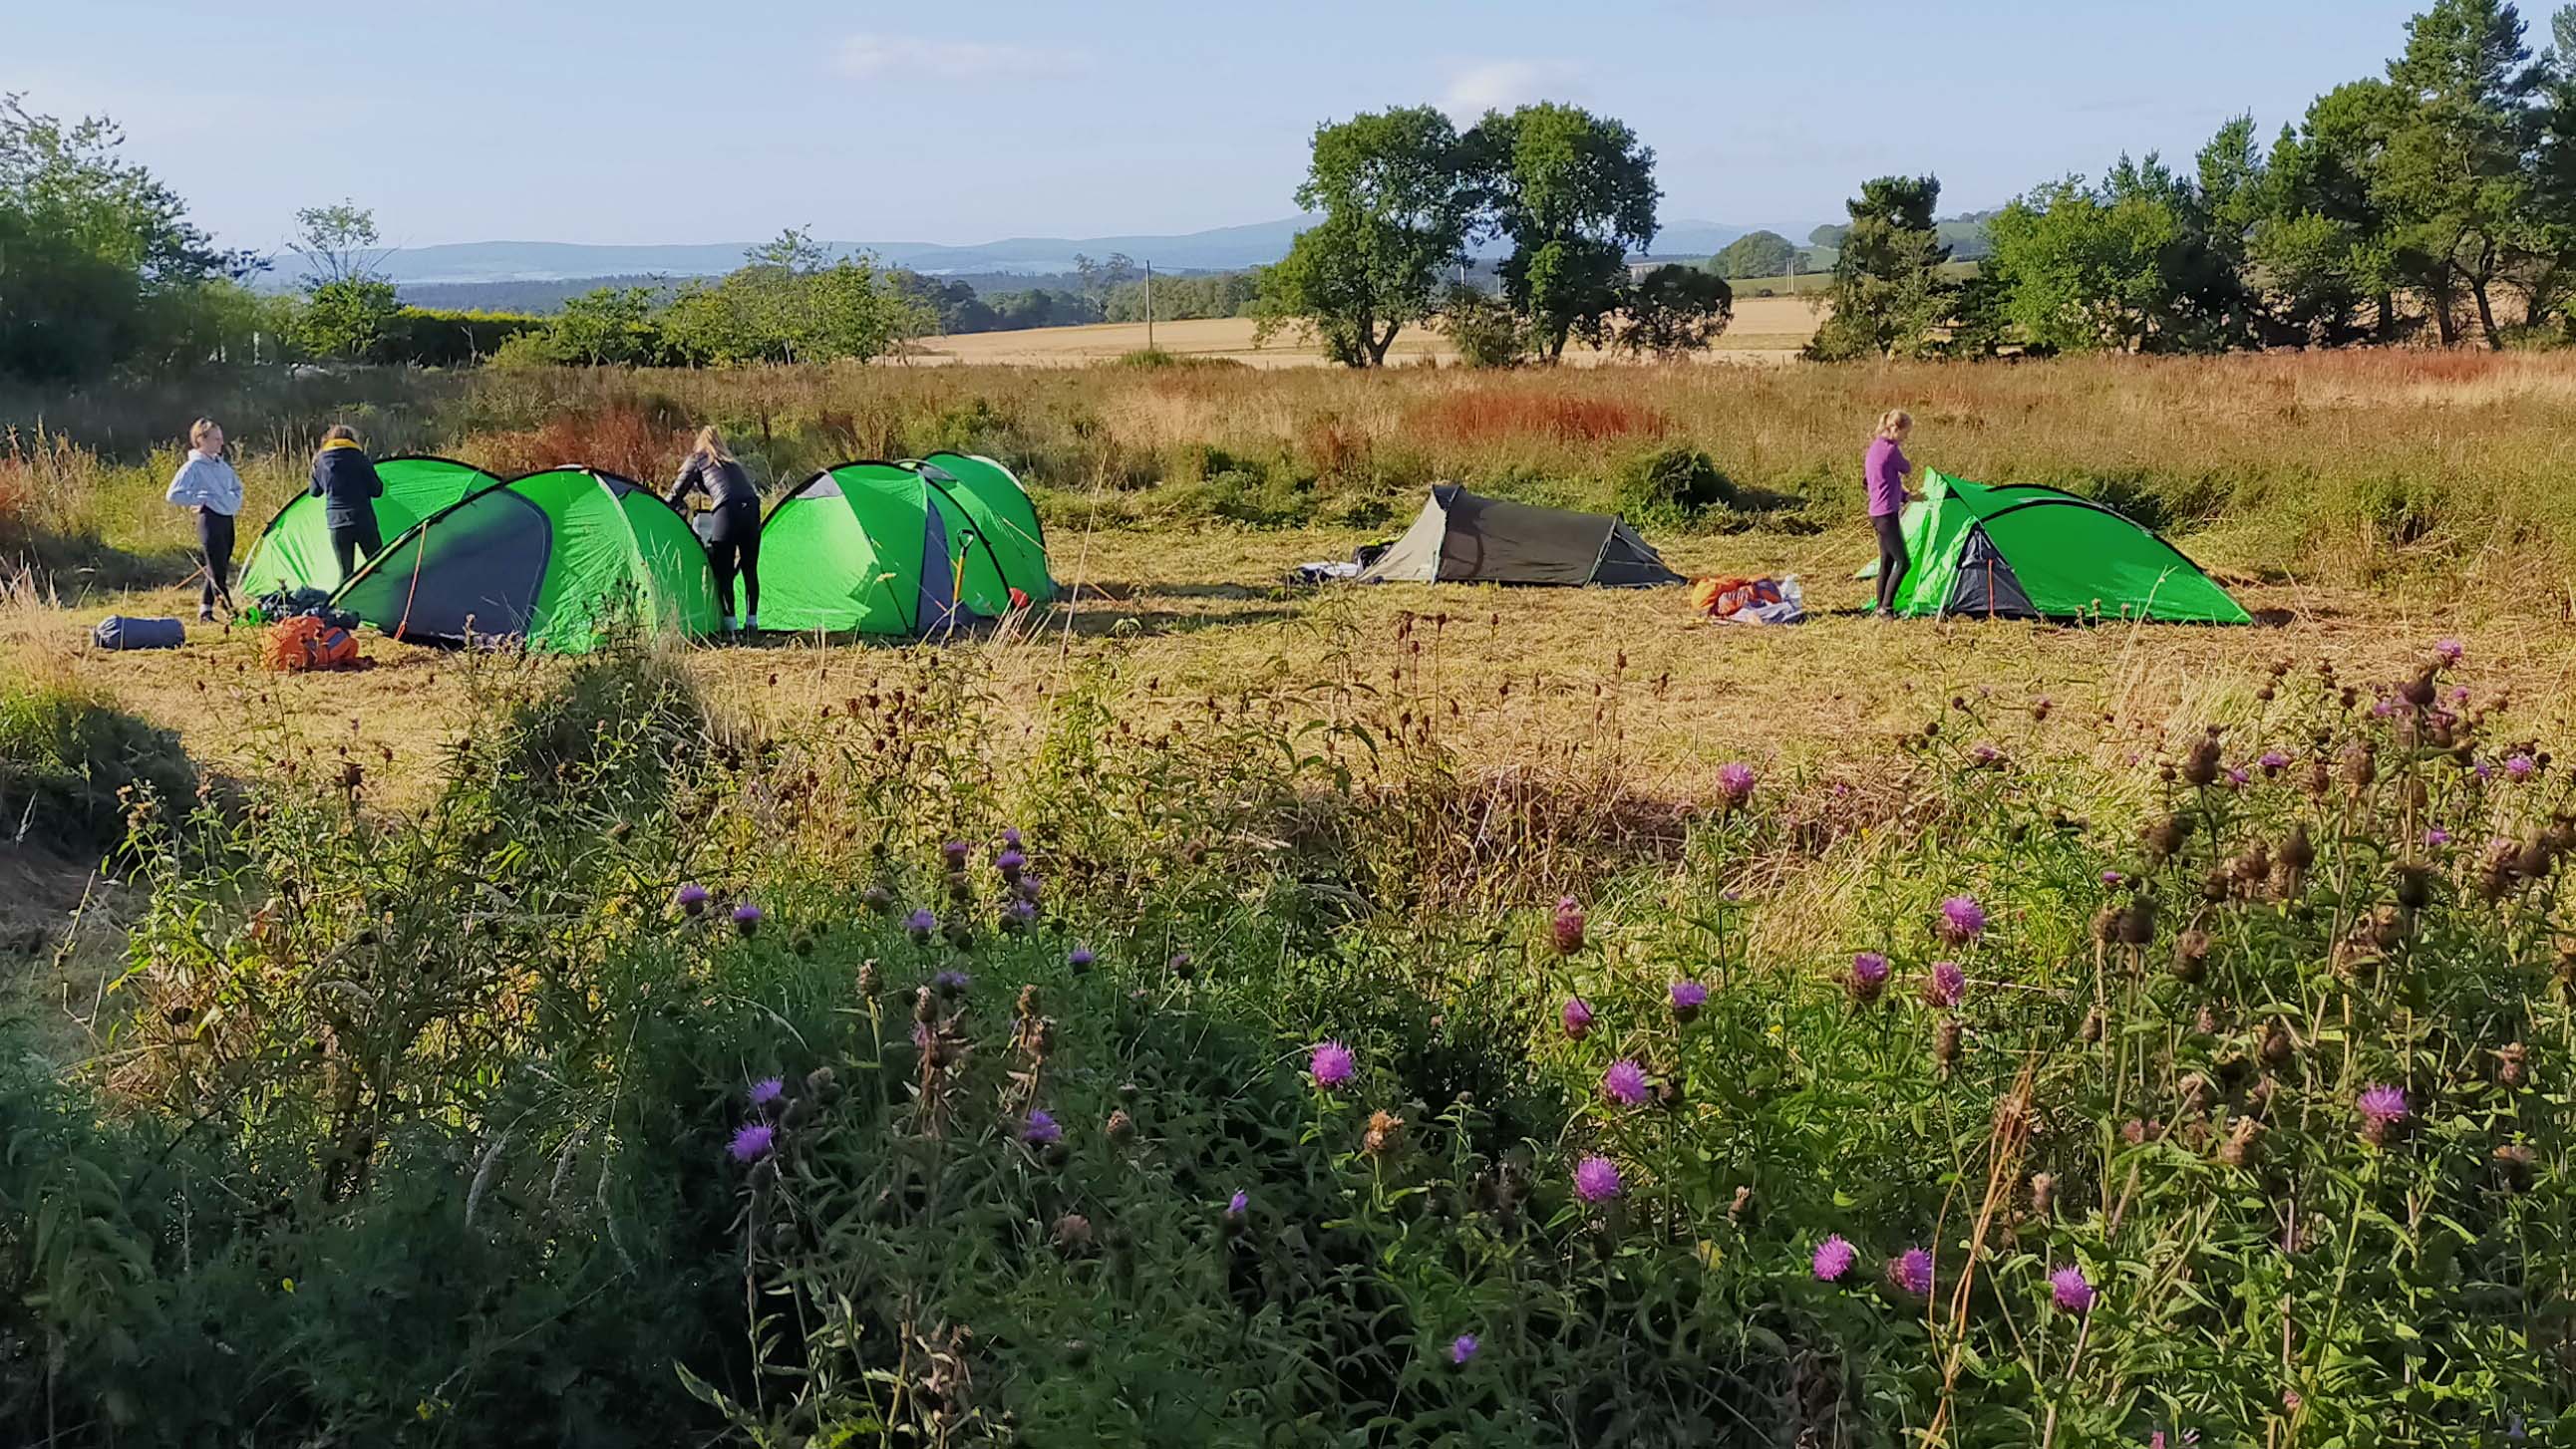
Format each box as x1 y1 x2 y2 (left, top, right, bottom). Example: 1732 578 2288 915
1360 484 1682 589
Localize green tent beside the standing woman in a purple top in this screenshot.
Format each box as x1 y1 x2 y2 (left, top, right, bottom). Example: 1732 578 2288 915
1870 468 2251 623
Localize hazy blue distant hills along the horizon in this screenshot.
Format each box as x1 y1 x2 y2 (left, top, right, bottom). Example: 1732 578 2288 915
337 216 1805 283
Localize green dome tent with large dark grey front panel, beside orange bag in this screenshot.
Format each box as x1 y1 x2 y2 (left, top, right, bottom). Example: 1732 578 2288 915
332 468 716 654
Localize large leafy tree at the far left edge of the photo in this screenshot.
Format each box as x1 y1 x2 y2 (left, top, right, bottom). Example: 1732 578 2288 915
0 96 257 381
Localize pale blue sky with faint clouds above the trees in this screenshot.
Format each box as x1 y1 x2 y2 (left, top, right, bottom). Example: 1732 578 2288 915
15 0 2431 247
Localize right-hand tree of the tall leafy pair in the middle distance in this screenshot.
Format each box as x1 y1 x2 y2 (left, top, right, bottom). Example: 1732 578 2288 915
1465 103 1662 363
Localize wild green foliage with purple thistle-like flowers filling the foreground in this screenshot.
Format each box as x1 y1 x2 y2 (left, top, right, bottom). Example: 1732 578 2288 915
0 641 2576 1446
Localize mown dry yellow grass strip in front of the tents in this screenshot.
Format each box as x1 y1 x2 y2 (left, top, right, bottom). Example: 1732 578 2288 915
20 530 2576 818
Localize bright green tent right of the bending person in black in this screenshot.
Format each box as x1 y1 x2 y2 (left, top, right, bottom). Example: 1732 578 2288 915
760 453 1056 636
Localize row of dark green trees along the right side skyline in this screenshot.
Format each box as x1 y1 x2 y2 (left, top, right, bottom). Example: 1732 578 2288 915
1811 0 2576 361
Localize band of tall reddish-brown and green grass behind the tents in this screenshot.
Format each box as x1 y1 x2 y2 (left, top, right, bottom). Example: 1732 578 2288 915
25 353 2576 595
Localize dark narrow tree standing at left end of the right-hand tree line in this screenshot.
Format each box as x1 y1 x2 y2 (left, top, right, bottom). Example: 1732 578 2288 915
1805 175 1953 363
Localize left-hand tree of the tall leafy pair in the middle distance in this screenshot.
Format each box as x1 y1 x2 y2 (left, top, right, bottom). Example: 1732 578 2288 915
1257 106 1476 368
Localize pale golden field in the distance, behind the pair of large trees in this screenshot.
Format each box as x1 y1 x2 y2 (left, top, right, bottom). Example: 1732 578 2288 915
907 296 1816 368
